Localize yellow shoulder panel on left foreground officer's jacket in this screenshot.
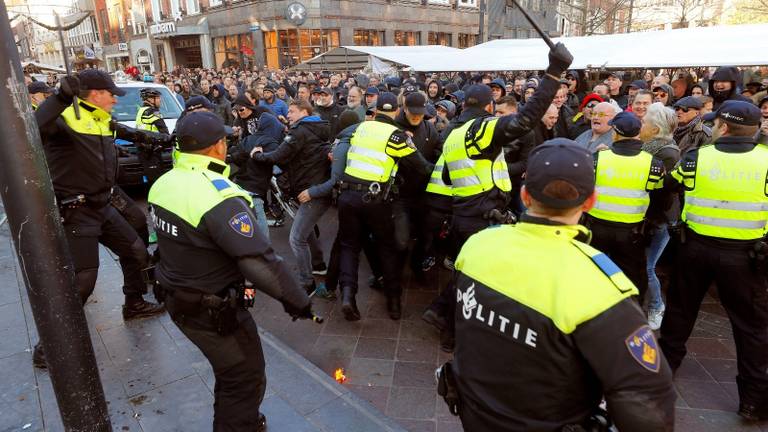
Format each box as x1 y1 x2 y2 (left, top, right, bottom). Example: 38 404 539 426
148 152 253 227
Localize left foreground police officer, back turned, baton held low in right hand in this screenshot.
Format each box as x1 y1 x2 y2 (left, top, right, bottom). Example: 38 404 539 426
149 112 313 431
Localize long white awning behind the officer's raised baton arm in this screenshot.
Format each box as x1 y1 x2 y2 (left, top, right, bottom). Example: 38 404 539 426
428 24 768 72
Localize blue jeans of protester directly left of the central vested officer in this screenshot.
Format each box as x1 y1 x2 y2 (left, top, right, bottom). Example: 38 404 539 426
288 198 331 286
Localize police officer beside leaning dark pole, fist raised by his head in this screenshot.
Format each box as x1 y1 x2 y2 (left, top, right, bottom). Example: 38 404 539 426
34 69 164 367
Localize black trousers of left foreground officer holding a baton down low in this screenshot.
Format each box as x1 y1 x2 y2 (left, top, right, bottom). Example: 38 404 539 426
166 296 267 432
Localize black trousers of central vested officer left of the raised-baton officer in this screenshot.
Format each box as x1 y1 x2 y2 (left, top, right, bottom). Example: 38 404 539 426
338 190 403 296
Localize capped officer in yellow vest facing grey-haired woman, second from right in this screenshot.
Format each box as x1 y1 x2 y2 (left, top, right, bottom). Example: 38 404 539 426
584 111 665 305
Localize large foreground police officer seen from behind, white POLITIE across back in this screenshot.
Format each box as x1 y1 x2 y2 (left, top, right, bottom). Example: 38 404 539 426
441 138 675 432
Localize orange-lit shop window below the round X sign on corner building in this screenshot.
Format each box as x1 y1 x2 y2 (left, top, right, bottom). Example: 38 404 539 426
264 29 339 69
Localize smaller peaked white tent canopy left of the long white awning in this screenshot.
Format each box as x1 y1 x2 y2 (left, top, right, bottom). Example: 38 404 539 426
294 45 461 72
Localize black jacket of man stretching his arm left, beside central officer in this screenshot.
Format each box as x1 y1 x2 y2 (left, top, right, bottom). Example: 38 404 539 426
253 115 332 197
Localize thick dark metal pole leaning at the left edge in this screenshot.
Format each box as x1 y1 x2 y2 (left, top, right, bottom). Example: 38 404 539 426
0 0 112 432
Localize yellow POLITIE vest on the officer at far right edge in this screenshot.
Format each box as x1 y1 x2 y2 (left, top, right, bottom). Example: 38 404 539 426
672 145 768 240
